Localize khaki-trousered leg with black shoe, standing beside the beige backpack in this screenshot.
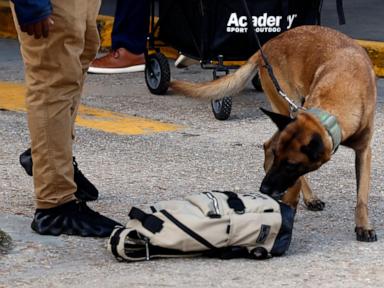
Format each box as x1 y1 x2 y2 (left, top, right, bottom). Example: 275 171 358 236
12 0 118 237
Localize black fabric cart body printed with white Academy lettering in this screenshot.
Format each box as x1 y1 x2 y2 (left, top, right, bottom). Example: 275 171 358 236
159 0 343 61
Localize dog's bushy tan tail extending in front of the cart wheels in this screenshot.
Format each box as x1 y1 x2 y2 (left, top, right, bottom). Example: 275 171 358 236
170 52 259 100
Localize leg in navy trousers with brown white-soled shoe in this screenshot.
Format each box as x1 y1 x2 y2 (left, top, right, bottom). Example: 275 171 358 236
88 0 149 73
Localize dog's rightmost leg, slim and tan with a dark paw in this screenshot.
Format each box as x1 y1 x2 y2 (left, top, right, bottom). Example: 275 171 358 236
355 146 377 242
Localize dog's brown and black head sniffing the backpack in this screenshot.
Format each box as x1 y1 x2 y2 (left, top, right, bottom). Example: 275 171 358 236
260 109 332 198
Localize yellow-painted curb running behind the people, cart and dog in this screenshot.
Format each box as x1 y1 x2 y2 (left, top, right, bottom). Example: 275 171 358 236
0 0 384 77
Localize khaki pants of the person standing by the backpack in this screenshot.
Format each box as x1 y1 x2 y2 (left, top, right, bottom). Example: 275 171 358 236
12 0 100 209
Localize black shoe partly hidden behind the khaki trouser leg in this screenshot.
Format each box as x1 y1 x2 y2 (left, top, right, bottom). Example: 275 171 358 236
20 148 99 201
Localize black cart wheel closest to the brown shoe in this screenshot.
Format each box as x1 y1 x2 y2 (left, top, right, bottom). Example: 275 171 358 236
145 53 171 95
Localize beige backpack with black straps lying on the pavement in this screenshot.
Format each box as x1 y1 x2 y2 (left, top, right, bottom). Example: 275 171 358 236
108 191 295 261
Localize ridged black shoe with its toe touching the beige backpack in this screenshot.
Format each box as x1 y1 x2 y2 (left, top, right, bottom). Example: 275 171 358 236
31 200 122 237
